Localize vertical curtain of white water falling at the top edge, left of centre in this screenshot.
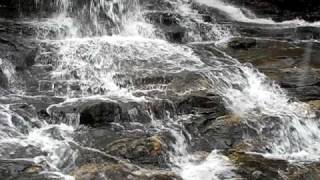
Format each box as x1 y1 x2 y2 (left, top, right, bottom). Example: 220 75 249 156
26 0 150 37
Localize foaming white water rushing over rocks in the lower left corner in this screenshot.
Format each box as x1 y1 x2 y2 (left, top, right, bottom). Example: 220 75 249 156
0 105 77 179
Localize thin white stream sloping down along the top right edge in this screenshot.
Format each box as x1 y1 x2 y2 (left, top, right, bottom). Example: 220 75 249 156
195 0 320 27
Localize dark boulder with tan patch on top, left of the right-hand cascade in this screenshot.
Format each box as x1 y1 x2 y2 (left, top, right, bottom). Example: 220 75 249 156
185 115 246 152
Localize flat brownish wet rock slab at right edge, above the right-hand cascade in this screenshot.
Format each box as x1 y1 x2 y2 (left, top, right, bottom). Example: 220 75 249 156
219 38 319 101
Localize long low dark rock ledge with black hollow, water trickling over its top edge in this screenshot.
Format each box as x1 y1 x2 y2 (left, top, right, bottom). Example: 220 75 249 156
48 99 175 127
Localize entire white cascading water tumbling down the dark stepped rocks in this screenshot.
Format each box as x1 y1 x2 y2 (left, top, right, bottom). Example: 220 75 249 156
0 0 320 180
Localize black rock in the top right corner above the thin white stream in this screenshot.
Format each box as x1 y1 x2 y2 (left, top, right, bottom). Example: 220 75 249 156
226 0 320 22
